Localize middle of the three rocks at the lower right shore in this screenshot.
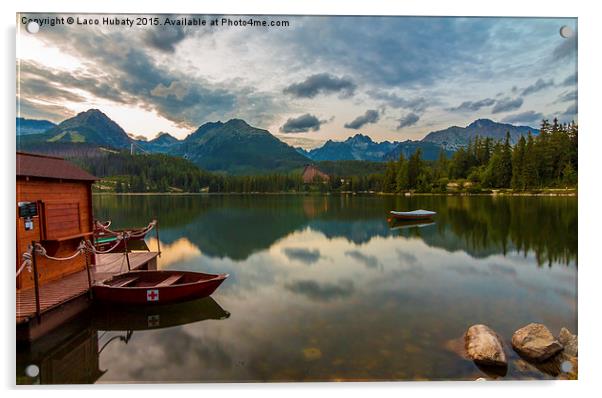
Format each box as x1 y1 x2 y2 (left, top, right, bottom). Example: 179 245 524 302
512 323 562 362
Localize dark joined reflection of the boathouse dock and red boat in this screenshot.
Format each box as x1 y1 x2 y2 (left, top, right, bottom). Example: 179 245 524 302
17 297 230 384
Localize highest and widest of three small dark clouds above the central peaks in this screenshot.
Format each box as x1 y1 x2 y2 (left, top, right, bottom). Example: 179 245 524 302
283 73 357 98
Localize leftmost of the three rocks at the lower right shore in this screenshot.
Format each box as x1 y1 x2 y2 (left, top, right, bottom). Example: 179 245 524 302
464 325 508 366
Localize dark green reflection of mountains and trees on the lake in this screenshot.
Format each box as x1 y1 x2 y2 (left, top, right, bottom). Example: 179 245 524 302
95 195 577 264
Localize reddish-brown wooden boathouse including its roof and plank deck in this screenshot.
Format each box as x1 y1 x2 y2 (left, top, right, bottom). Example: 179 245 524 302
16 152 158 341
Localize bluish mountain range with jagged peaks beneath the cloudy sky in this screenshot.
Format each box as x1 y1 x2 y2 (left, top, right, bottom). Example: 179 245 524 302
17 109 538 174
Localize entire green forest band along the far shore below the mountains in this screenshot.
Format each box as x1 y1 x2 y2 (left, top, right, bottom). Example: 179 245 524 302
73 119 578 193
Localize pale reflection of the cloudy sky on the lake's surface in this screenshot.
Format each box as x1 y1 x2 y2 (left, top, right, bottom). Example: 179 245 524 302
96 224 577 382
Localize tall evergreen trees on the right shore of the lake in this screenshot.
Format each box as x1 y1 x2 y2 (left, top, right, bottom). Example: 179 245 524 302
382 119 578 192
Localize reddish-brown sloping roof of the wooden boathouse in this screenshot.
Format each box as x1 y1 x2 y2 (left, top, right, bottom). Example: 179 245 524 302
17 152 98 181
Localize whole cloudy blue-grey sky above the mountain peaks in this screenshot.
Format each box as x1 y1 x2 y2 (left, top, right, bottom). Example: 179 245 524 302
17 14 577 147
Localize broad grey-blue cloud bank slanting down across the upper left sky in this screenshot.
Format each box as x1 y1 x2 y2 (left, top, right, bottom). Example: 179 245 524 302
16 30 284 128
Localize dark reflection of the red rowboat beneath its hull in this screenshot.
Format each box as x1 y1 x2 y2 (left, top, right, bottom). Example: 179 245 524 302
92 297 230 330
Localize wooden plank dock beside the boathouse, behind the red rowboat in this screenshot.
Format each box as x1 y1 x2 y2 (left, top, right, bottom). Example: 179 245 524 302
16 252 159 339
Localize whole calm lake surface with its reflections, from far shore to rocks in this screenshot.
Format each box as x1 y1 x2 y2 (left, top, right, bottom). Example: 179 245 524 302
17 195 578 383
